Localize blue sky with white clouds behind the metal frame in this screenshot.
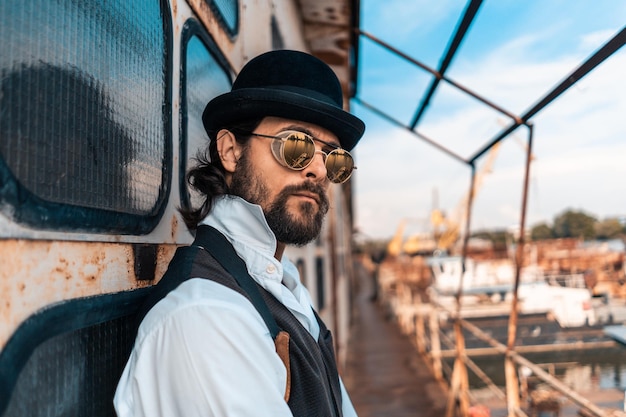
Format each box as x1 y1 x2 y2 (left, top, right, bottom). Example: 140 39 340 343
351 0 626 239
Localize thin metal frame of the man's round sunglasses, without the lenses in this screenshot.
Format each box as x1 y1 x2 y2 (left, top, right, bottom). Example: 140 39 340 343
240 130 357 184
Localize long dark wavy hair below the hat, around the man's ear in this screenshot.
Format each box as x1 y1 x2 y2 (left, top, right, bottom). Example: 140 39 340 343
178 119 262 230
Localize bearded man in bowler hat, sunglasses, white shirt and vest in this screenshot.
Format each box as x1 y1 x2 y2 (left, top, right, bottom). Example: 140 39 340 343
114 51 365 417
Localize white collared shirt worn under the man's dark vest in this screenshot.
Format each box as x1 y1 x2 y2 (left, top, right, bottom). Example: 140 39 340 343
114 196 356 417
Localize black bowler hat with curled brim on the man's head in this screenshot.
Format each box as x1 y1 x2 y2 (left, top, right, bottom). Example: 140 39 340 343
202 50 365 150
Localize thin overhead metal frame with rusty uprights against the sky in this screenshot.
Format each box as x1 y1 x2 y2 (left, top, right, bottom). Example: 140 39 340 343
352 0 626 416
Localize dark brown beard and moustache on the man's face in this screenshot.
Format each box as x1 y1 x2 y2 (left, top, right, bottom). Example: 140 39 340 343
230 152 330 246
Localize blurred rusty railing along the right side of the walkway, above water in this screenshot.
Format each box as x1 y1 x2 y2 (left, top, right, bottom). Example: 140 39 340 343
379 264 626 417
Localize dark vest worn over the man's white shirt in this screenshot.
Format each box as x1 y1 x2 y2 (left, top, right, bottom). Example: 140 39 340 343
139 226 342 417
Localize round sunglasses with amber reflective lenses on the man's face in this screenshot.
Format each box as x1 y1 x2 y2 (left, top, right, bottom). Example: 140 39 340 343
246 130 356 184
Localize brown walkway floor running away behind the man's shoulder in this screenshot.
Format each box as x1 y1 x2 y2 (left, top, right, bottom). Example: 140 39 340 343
342 263 447 417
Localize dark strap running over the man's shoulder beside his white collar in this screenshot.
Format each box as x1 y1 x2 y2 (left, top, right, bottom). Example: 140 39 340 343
193 225 280 340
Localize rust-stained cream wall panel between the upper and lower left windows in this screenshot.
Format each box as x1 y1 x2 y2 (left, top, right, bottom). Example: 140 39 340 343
0 239 176 347
